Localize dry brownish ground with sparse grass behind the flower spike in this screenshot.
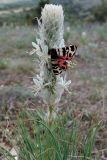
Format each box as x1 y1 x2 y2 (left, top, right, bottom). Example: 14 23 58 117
0 24 107 156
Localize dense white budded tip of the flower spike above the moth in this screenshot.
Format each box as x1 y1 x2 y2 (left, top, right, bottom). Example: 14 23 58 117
40 4 64 48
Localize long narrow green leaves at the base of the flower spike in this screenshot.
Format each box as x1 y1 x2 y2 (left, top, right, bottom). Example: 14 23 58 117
1 111 99 160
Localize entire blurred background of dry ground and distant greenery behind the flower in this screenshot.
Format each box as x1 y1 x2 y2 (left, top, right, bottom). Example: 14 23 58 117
0 0 107 129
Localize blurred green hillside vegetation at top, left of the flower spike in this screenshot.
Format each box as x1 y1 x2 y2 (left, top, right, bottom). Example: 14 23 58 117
0 0 49 26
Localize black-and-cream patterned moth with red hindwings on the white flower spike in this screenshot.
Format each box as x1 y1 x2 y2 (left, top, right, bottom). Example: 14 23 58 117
48 45 77 75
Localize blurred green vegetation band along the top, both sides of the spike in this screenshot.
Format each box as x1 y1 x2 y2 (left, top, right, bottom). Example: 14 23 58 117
0 0 107 26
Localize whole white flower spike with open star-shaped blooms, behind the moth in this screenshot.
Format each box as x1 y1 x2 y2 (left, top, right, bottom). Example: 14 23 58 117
30 4 71 105
